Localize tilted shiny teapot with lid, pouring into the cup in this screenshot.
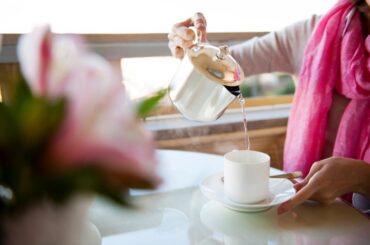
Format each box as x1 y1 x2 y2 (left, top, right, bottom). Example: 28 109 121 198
169 28 244 122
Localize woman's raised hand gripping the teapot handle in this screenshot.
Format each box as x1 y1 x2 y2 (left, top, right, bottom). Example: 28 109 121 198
168 13 207 59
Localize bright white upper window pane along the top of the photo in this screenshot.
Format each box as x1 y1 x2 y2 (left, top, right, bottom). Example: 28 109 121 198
0 0 337 33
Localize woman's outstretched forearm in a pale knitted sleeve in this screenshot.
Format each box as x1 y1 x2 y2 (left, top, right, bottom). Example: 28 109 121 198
230 15 319 76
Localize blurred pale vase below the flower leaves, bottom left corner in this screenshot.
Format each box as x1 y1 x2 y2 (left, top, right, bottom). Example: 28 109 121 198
1 196 101 245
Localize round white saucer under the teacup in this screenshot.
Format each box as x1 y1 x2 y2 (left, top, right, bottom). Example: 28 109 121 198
200 172 295 212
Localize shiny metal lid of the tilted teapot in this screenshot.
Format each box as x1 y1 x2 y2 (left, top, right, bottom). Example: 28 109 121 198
187 31 244 86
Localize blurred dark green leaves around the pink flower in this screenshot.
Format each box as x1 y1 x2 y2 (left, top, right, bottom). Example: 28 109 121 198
0 76 138 212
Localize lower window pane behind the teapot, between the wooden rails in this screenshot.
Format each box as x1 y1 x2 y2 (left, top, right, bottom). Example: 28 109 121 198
121 57 295 101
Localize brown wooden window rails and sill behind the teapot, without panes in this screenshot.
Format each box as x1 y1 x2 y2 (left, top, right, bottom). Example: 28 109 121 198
0 32 292 165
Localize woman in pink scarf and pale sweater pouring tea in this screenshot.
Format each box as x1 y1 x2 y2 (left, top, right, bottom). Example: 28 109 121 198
168 0 370 214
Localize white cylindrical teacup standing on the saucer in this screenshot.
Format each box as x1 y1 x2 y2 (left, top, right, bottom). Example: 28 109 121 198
224 150 270 204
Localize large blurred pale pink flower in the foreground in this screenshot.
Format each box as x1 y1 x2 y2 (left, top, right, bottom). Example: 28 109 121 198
18 26 158 188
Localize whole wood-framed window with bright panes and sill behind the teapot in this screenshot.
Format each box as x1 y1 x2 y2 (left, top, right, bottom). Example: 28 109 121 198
0 0 337 163
